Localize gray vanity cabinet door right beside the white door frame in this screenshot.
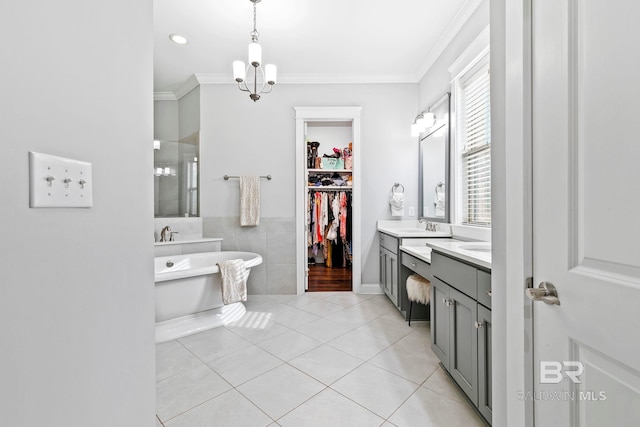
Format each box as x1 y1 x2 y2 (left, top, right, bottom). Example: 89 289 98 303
478 305 493 423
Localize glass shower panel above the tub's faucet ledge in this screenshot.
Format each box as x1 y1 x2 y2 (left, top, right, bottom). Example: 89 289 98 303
153 133 200 218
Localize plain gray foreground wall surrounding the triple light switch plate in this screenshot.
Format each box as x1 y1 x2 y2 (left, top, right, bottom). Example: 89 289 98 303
0 0 155 427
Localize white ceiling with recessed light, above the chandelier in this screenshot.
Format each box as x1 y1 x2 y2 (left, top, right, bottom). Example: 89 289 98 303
154 0 480 94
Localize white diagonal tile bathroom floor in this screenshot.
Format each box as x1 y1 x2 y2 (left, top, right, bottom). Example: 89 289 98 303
156 292 484 427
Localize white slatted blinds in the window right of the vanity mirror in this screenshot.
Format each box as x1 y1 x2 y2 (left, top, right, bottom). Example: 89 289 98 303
460 64 491 226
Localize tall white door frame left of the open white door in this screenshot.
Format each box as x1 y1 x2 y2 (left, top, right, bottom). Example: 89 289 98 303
490 0 535 427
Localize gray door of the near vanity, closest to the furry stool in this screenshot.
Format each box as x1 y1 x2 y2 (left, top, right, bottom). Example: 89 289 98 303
429 277 451 370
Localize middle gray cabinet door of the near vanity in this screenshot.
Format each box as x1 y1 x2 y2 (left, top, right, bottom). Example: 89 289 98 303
449 288 478 406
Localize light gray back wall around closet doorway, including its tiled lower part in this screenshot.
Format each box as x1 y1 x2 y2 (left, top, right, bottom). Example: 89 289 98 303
200 84 418 293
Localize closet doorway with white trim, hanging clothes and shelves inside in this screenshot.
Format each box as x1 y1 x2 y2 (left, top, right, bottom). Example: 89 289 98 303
295 107 361 294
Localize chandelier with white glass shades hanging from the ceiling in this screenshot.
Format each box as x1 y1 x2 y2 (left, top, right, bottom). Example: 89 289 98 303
233 0 277 102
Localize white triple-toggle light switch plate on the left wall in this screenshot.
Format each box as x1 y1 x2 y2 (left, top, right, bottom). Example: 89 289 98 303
29 151 93 208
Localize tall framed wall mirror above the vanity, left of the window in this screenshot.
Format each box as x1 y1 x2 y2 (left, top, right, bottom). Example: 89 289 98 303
418 92 451 222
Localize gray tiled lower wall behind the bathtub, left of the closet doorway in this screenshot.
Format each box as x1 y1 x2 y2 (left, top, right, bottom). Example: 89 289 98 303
203 217 297 295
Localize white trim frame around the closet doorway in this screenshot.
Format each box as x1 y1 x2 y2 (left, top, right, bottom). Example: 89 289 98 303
293 106 362 295
